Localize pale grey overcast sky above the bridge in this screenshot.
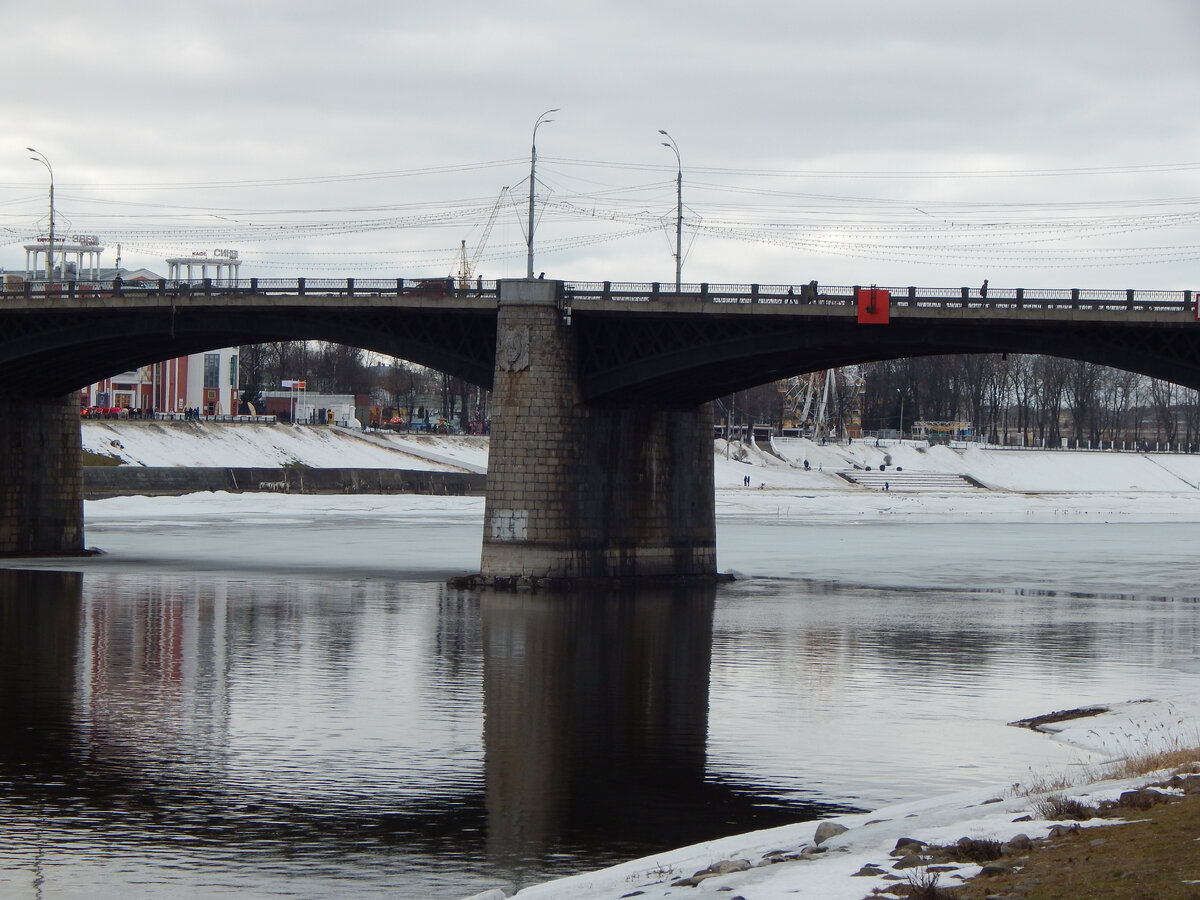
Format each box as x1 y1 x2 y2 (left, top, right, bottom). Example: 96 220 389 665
0 0 1200 289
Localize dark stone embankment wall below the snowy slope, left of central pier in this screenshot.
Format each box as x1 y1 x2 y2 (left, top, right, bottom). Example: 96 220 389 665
83 466 487 500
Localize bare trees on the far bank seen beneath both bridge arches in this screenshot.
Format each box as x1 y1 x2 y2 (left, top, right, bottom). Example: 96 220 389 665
240 341 1200 446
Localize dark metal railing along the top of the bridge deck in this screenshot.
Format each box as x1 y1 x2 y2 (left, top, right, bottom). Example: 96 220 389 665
0 276 1198 313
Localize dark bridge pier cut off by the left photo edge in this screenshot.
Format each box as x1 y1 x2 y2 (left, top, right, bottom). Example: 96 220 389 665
0 389 83 557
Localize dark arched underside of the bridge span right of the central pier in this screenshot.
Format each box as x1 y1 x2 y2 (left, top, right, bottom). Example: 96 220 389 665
574 310 1200 406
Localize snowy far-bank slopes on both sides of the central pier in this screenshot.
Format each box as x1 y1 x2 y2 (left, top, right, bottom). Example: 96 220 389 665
83 421 1200 509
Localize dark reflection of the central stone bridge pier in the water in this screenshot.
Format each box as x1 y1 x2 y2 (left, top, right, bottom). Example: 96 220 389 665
480 588 833 883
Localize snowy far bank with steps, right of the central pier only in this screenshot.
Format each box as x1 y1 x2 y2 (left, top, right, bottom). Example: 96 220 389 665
715 439 1200 522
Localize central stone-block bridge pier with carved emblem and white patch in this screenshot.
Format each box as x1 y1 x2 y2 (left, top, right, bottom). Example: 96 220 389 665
481 280 716 587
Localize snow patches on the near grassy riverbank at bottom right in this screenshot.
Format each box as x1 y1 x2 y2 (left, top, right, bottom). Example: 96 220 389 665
476 696 1200 900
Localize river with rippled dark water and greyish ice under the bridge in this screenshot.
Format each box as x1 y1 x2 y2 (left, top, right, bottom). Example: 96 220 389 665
0 498 1200 900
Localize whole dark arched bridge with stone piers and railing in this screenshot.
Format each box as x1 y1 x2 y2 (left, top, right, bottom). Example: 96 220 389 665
0 278 1200 586
